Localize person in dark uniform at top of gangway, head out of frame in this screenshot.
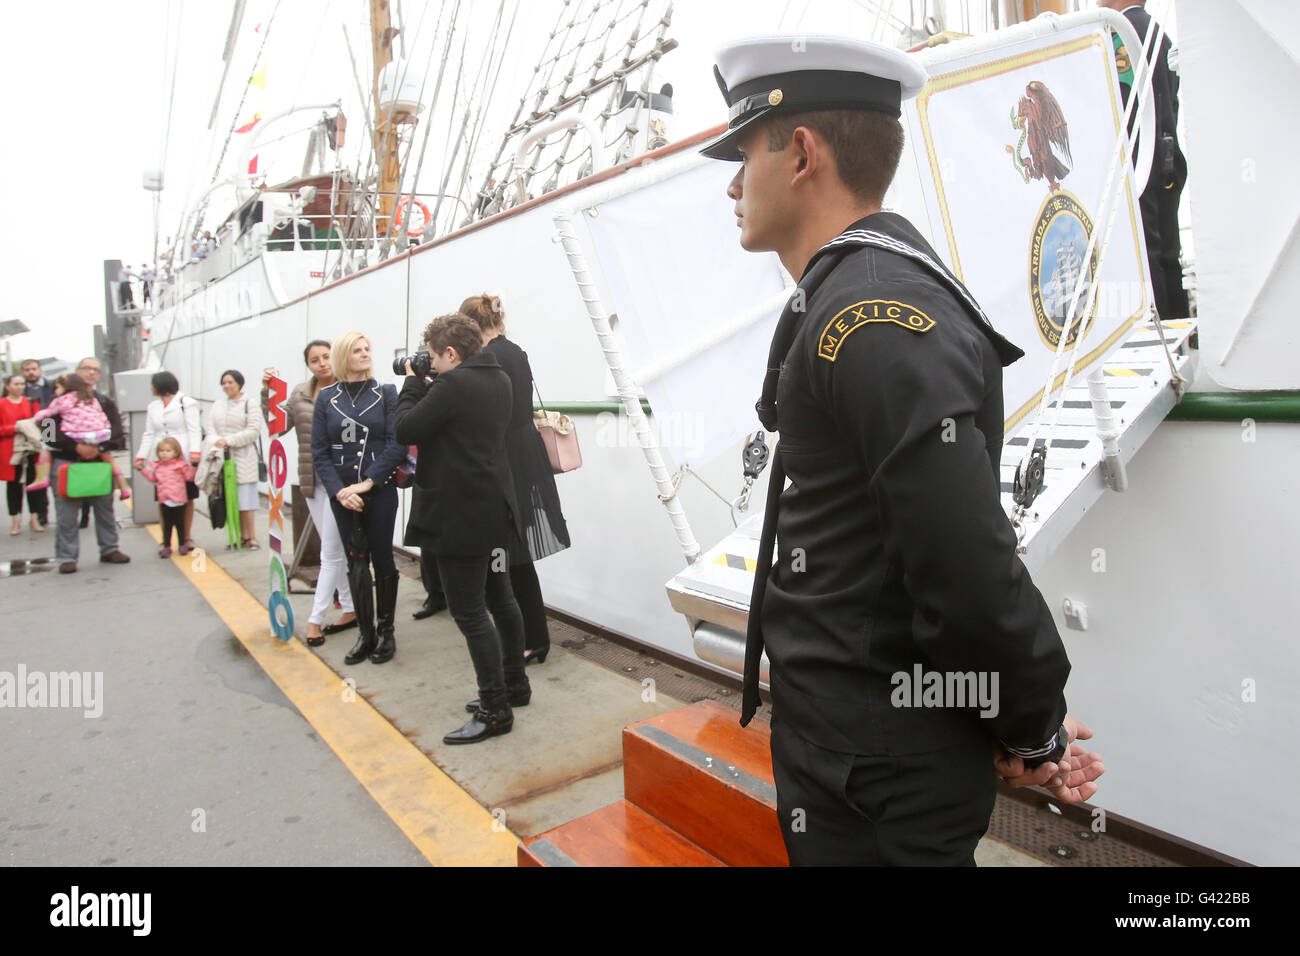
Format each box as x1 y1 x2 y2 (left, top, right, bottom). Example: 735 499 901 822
1097 0 1191 320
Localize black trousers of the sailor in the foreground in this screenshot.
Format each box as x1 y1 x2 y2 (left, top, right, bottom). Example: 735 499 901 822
772 706 996 866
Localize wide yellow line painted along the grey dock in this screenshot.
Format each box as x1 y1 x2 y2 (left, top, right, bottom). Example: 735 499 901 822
148 524 519 866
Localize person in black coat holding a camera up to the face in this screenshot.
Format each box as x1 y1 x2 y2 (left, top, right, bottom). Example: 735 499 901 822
397 313 532 744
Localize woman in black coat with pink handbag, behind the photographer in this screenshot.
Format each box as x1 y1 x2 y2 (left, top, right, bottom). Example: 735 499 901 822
460 293 569 663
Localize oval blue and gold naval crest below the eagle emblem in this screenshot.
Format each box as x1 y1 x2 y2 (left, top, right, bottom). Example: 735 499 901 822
1030 189 1097 349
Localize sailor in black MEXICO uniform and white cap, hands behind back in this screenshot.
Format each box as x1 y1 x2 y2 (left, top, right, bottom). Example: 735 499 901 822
702 36 1104 865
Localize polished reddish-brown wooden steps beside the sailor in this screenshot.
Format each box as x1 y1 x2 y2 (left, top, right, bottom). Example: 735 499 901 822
519 701 787 866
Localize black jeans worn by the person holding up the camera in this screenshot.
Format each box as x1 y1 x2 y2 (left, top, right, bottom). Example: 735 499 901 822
438 554 528 710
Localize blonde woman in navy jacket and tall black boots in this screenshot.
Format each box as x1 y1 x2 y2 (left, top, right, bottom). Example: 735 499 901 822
312 332 406 663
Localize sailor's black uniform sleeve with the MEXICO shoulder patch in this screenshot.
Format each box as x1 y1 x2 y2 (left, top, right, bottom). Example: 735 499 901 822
811 280 1070 748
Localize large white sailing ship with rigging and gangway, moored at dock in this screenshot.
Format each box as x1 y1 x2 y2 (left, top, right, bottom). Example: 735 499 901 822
108 0 1300 865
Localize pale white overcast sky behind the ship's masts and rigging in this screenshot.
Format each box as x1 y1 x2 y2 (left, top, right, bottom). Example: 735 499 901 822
0 0 1138 359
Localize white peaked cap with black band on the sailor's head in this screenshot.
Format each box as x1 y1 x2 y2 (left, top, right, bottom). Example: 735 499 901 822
701 34 927 161
